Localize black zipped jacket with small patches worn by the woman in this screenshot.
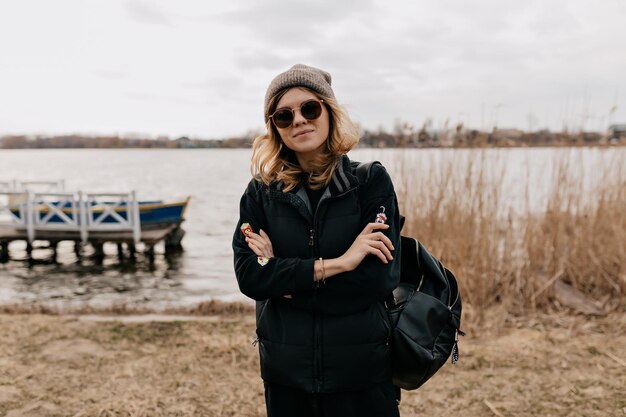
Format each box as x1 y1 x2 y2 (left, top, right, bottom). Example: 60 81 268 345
233 156 400 392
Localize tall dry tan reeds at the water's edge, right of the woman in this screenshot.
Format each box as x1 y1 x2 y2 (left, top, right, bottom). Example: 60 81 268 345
394 148 626 323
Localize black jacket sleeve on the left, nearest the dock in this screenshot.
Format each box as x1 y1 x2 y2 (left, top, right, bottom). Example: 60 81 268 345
233 180 315 301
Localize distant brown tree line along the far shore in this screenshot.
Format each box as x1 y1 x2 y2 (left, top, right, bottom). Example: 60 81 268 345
0 123 626 149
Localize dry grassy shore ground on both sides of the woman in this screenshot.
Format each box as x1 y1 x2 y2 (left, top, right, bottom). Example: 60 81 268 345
0 314 626 417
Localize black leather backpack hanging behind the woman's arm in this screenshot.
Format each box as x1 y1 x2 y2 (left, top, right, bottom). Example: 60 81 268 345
356 162 458 390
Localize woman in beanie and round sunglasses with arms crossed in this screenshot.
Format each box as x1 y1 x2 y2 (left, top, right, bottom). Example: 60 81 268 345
233 65 400 417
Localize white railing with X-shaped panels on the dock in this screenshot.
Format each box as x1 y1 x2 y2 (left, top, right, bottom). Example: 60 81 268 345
0 190 141 243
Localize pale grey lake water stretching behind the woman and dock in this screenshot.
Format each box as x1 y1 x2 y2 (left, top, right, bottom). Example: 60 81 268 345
0 147 626 308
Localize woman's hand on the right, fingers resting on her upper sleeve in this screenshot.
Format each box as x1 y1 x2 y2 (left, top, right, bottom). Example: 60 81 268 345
341 223 395 271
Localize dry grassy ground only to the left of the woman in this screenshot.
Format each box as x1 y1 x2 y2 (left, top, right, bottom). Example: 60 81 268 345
0 314 263 417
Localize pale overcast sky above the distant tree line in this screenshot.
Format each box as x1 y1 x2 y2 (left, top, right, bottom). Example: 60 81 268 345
0 0 626 138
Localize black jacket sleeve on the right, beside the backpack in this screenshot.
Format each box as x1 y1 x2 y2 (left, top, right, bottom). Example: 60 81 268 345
292 165 400 315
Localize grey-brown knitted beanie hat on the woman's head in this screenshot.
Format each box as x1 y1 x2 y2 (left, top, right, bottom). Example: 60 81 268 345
265 64 335 120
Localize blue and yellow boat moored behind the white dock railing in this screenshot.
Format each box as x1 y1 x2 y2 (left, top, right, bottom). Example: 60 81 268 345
0 181 190 245
